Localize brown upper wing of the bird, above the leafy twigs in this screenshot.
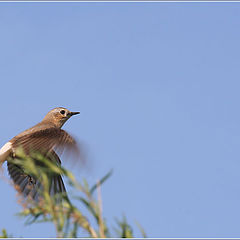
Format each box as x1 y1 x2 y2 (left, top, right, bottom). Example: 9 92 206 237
10 127 79 158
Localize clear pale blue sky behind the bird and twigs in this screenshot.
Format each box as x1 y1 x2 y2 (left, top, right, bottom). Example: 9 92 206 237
0 3 240 237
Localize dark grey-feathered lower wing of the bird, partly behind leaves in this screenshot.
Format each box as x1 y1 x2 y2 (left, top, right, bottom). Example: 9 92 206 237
7 151 66 200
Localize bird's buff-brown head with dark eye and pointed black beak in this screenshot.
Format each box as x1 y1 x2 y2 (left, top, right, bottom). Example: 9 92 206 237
43 107 80 128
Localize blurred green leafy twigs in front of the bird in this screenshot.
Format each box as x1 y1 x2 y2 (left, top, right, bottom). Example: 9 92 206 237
2 149 146 238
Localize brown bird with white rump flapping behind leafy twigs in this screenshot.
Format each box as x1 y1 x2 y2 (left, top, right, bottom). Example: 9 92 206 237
0 107 80 201
